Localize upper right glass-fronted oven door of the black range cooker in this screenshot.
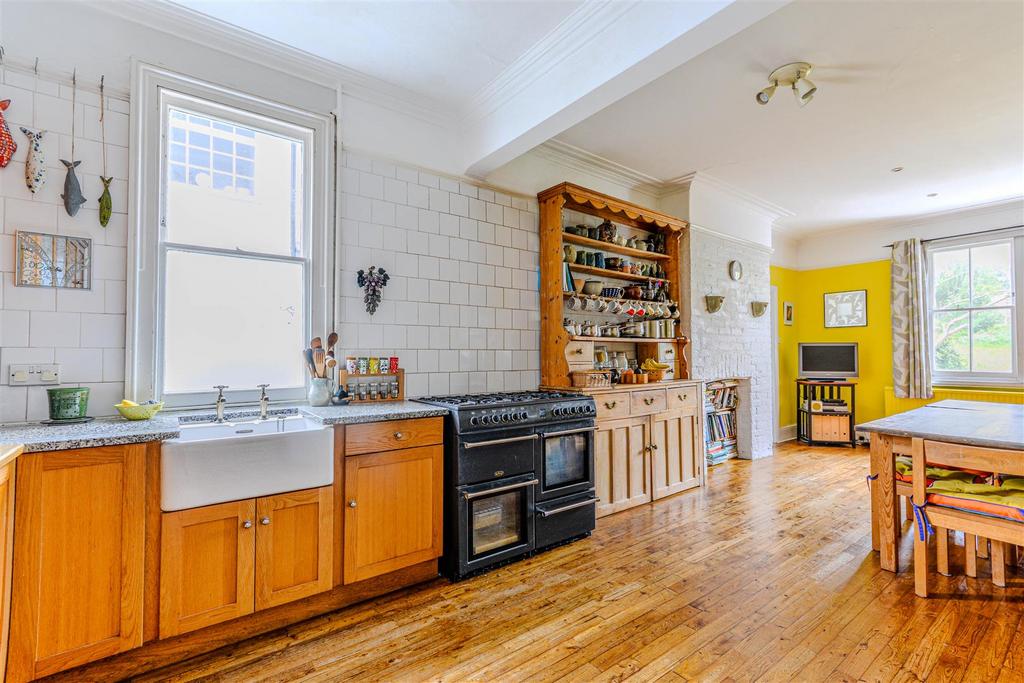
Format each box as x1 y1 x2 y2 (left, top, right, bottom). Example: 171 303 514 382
537 422 596 501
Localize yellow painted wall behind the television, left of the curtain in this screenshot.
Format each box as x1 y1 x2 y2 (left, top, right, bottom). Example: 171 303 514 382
771 260 892 425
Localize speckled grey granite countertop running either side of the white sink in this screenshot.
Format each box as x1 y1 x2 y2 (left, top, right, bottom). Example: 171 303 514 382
0 400 447 453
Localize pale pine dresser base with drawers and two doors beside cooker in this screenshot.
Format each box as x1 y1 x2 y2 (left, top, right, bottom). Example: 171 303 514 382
593 380 705 517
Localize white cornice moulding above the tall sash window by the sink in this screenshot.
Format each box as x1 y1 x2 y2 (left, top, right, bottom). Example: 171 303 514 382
91 0 455 126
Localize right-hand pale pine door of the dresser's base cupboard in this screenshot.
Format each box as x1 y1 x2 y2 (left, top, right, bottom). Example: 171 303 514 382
650 411 701 501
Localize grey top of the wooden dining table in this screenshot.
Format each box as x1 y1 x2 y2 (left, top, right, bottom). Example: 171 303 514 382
857 400 1024 451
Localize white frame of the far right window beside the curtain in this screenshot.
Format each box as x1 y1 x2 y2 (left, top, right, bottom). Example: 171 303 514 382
925 228 1024 388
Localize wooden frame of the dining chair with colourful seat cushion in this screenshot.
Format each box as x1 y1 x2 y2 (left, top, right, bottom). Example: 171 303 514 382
912 438 1024 598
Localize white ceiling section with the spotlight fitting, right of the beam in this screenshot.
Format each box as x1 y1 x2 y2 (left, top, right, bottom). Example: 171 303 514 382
558 1 1024 233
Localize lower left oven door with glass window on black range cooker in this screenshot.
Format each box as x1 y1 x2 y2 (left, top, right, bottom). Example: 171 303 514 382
457 473 538 575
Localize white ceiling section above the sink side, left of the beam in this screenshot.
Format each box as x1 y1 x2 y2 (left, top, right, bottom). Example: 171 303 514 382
175 0 583 105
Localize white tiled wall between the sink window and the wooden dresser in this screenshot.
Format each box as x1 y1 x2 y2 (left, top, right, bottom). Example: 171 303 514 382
337 152 540 396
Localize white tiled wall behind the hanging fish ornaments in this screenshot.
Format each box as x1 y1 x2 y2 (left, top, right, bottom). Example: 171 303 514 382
0 69 128 422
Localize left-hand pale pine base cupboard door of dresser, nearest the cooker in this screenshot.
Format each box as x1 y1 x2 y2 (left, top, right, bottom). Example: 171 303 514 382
594 416 651 517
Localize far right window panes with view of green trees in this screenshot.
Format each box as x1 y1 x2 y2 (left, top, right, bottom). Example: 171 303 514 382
929 237 1021 383
